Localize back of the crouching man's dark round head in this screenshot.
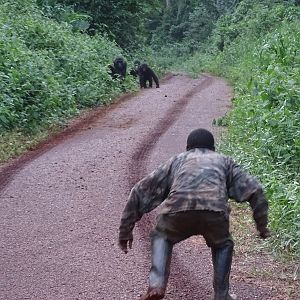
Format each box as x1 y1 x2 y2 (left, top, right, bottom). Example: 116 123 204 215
186 128 215 151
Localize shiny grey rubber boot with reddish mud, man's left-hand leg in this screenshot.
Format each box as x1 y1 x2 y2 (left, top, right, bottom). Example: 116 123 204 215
140 235 173 300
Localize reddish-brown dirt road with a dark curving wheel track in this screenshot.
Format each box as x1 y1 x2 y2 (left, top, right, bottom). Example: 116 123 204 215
0 75 292 300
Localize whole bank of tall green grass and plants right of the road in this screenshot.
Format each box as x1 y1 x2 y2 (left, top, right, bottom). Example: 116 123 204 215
179 0 300 257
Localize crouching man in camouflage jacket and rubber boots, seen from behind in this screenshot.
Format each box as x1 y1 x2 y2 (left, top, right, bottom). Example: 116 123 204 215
119 128 270 300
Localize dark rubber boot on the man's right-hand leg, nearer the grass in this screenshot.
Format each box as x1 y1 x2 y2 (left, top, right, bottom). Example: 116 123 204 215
211 242 237 300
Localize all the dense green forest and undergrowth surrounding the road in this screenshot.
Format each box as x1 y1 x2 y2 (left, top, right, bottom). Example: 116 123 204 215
0 0 300 257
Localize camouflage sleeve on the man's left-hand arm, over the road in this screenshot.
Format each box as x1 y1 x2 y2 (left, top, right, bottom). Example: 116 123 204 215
119 160 172 240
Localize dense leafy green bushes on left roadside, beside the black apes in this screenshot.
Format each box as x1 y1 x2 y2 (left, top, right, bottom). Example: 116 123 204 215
0 0 135 131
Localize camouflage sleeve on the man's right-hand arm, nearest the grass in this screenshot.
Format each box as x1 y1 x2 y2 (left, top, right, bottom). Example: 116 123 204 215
228 161 268 232
